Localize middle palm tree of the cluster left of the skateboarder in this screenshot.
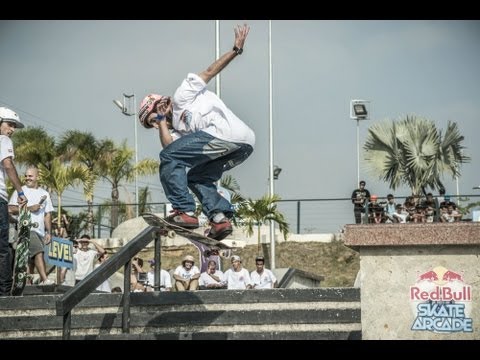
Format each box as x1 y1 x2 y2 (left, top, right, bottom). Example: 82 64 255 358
58 130 114 236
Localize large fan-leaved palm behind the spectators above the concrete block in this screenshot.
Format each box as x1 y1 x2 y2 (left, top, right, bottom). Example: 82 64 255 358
363 116 470 195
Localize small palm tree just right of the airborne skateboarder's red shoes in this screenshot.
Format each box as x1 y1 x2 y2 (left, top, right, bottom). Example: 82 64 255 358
236 194 289 253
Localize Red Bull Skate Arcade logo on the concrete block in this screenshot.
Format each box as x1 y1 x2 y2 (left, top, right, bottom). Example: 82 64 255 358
409 266 473 333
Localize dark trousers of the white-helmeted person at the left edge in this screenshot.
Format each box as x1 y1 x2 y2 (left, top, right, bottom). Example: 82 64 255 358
0 199 12 296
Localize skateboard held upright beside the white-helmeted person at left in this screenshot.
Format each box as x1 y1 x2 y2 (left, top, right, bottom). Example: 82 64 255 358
11 206 38 296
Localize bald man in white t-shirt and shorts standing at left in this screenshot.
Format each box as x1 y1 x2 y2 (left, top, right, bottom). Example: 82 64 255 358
8 166 55 285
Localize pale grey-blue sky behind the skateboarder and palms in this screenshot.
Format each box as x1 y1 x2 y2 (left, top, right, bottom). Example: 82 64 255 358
0 20 480 232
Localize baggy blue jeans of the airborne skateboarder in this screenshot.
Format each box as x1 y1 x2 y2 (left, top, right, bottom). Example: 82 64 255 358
160 131 253 220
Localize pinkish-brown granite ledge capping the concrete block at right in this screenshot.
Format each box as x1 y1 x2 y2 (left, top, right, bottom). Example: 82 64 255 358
344 222 480 248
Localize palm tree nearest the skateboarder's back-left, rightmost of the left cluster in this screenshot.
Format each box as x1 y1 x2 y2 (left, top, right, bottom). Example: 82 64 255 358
102 141 159 228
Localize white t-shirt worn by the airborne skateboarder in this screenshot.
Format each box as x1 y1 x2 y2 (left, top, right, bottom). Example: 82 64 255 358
172 73 255 147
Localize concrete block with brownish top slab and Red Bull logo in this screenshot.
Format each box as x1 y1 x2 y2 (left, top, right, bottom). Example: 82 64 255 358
345 223 480 340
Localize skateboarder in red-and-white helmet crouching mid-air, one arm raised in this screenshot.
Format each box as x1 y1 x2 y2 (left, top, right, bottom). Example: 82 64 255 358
138 25 255 240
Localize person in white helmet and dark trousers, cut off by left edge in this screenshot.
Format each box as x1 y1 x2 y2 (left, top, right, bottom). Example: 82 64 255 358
0 107 27 296
